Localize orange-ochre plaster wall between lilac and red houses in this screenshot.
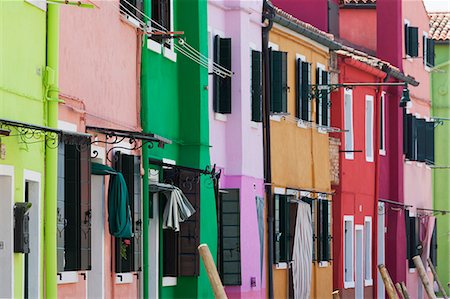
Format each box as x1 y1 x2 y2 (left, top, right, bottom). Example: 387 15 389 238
269 24 332 298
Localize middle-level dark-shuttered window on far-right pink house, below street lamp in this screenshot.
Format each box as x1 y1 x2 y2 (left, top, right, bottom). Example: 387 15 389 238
403 112 434 164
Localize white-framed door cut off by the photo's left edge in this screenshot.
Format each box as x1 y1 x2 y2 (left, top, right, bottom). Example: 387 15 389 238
0 165 14 298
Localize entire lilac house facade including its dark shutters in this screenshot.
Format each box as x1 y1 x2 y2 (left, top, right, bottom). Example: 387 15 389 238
208 1 266 298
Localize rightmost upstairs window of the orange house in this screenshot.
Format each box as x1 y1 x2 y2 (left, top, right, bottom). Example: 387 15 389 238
316 65 330 126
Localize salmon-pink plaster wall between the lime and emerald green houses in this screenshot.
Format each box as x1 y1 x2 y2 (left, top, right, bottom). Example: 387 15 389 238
58 0 140 298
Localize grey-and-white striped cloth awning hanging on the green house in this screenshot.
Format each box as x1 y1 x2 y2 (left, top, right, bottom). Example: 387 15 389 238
149 183 195 232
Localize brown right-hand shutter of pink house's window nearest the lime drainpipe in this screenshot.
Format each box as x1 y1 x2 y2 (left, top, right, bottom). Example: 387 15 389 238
79 146 91 270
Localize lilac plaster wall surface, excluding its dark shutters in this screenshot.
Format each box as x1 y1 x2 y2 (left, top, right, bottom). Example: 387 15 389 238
208 0 266 298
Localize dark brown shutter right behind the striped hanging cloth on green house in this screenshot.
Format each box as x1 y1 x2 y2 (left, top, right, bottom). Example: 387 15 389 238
178 170 200 276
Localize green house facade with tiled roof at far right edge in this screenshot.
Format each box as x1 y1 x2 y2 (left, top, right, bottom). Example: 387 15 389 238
429 13 450 292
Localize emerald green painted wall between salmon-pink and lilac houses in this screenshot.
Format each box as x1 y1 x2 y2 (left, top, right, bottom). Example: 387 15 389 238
141 0 217 298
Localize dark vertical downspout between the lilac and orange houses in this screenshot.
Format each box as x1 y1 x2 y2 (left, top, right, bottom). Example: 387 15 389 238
262 0 274 299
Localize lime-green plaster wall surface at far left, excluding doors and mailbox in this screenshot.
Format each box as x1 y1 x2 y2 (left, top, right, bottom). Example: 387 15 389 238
0 0 46 298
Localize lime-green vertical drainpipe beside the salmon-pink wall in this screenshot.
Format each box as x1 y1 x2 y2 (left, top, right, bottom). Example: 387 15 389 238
44 4 59 298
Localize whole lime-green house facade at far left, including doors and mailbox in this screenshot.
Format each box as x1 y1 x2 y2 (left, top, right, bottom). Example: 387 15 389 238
0 1 46 298
